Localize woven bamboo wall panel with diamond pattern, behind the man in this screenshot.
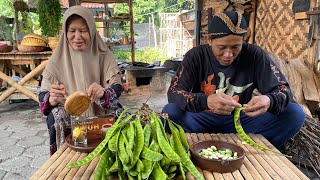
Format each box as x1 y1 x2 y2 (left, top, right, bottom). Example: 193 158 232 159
254 0 313 64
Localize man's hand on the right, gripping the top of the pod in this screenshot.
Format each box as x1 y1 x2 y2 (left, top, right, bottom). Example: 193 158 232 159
243 95 270 117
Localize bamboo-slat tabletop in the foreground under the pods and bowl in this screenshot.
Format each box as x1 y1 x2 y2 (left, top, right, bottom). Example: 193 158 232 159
31 133 309 180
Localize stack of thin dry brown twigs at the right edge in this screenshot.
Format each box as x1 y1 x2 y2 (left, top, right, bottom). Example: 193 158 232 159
288 116 320 177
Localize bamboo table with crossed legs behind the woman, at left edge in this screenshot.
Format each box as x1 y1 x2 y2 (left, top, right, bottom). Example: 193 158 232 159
0 51 52 103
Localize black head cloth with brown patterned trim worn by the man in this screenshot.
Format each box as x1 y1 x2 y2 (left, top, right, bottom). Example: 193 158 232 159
208 11 247 39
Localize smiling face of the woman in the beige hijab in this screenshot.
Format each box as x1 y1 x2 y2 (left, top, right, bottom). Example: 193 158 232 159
67 17 90 51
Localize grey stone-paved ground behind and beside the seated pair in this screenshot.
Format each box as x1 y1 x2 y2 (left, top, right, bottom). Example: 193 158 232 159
0 90 320 180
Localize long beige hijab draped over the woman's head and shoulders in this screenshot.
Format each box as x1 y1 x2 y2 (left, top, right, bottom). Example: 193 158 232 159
41 6 121 115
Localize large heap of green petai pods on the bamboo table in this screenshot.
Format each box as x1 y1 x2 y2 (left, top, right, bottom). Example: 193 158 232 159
67 106 204 180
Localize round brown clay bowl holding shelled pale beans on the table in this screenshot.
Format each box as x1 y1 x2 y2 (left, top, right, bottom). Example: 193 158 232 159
190 140 244 173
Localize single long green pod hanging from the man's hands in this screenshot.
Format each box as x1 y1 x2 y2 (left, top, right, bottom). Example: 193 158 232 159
234 107 291 157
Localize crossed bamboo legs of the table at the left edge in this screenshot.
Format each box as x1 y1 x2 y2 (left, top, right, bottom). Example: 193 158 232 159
0 60 48 102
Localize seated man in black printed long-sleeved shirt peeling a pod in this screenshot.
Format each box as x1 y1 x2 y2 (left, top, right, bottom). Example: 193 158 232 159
163 11 305 148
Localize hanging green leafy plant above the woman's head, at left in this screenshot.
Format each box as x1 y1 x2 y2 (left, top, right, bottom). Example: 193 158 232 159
36 0 62 37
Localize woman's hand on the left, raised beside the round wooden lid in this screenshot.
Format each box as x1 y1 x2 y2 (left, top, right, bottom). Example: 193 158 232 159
49 84 66 106
